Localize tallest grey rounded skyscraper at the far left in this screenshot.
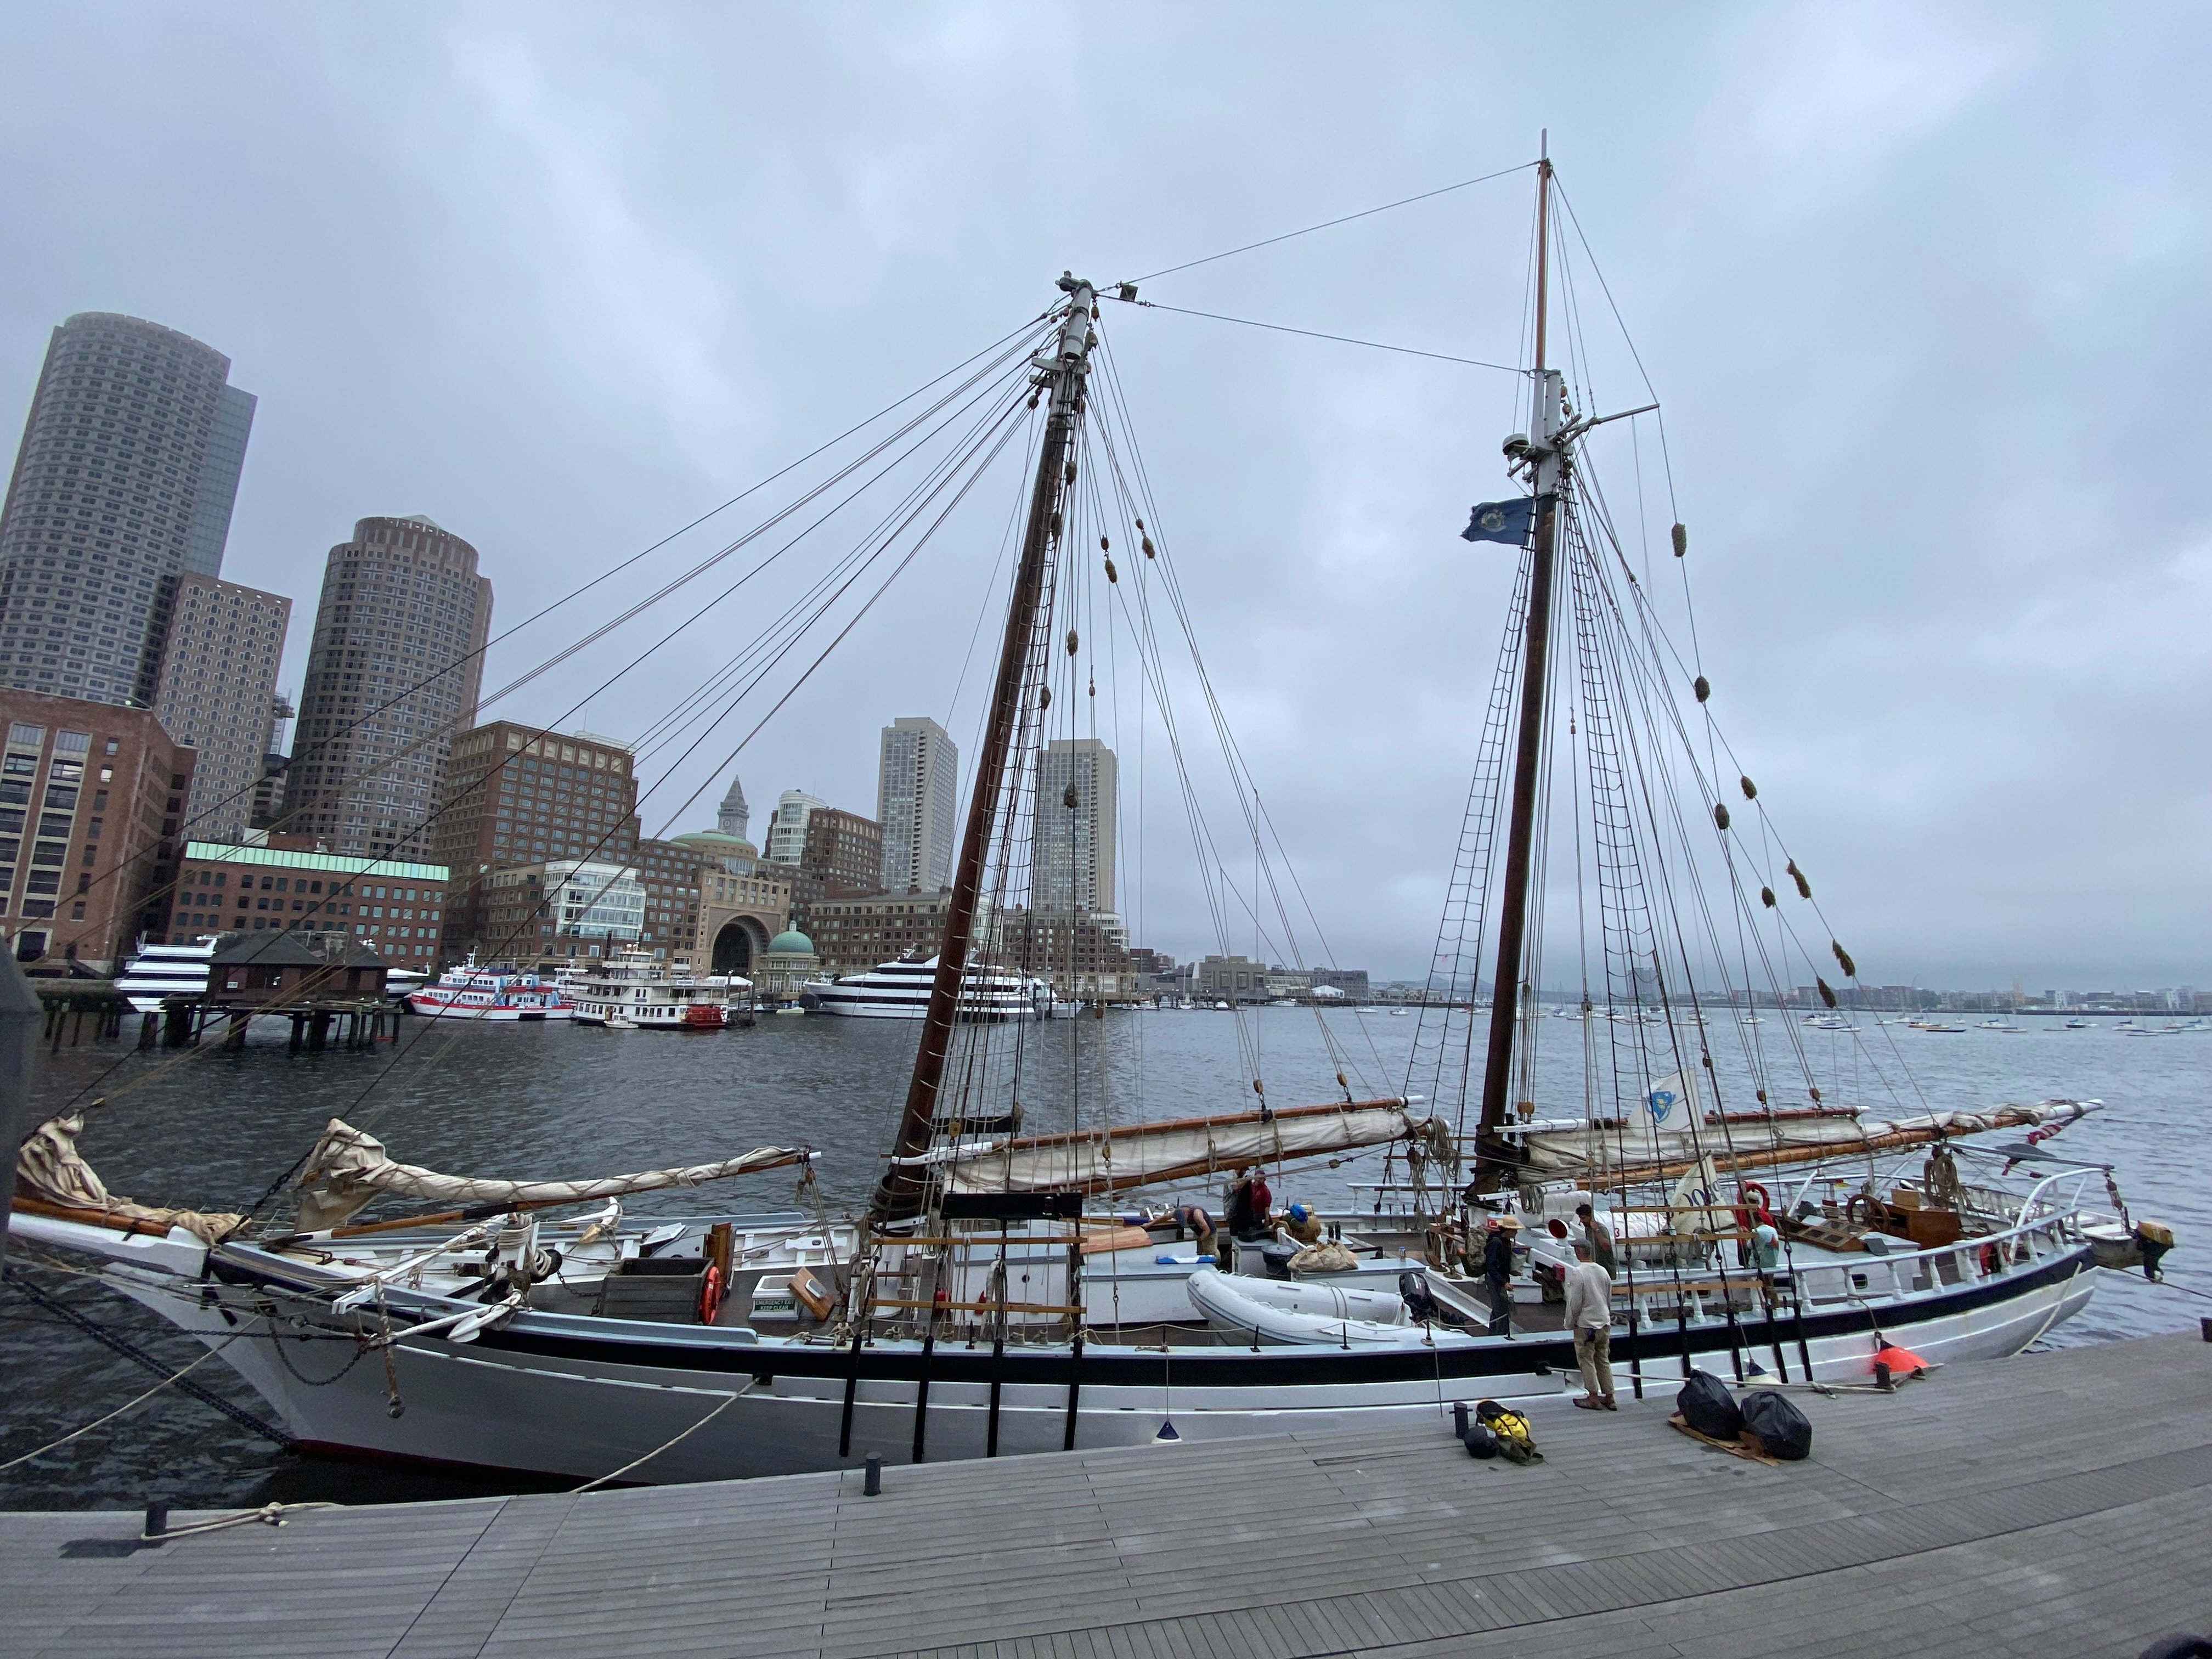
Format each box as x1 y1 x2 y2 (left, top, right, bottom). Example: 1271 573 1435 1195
0 312 255 708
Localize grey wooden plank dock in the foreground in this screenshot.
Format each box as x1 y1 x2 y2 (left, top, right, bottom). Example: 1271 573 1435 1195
0 1336 2212 1659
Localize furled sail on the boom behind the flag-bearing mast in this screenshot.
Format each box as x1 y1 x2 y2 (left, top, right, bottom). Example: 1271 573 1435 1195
1504 1097 2097 1186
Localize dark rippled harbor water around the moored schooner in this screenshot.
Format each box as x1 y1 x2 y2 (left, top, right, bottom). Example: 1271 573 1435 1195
0 1009 2212 1509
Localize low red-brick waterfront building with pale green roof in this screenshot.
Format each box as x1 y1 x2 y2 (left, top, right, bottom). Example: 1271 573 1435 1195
168 834 452 973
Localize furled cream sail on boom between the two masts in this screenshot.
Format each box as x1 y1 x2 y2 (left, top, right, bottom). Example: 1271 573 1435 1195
900 1099 1449 1192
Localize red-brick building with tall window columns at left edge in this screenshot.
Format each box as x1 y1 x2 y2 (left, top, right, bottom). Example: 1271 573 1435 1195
0 688 197 973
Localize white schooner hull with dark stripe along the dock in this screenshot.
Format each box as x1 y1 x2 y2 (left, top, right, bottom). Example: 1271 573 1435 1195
64 1217 2095 1482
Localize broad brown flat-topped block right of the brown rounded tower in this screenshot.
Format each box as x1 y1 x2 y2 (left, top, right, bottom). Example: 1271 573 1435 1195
425 721 637 956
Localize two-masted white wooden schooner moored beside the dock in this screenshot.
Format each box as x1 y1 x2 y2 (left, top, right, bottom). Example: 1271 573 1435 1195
15 161 2137 1480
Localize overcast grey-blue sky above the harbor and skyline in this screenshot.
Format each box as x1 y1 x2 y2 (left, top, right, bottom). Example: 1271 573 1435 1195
0 2 2212 989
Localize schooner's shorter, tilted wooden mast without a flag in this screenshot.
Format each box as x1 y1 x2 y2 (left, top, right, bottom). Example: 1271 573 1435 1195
870 274 1097 1226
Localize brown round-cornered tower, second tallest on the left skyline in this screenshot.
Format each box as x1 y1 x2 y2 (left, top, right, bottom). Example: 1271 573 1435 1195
285 517 491 858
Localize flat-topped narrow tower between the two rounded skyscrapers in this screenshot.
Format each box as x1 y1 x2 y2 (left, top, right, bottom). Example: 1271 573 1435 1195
153 571 292 840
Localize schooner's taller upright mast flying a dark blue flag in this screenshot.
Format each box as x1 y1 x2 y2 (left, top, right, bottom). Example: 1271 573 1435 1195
1475 144 1566 1190
